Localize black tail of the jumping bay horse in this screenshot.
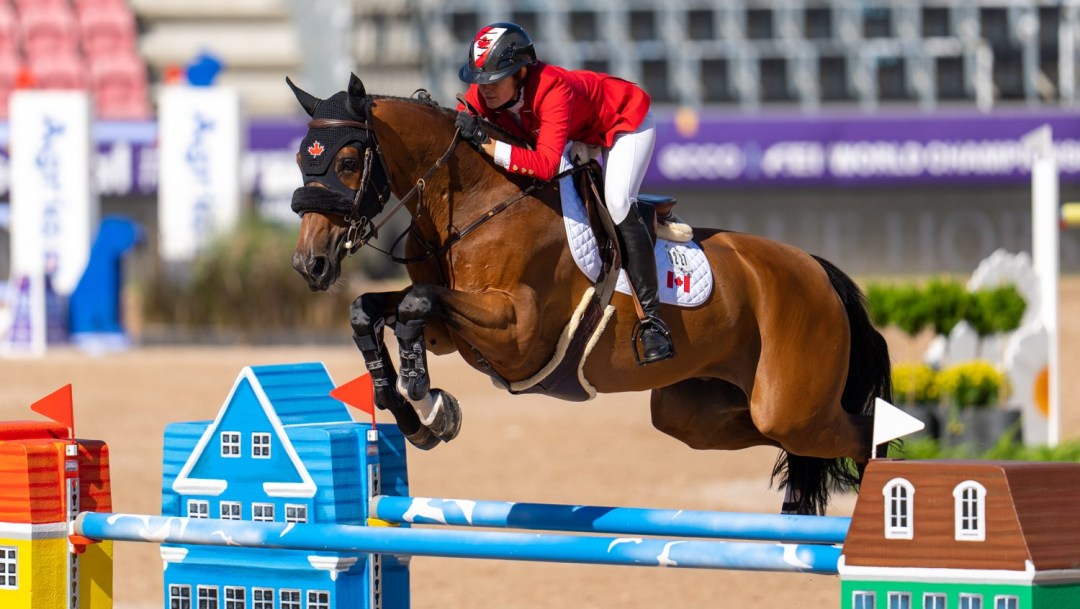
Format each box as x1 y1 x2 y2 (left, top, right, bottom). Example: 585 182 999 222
772 256 892 514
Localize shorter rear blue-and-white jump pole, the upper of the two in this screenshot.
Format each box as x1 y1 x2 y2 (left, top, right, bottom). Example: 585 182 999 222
370 496 851 543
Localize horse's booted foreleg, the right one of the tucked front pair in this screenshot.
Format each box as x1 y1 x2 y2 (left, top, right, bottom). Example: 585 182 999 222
394 284 461 442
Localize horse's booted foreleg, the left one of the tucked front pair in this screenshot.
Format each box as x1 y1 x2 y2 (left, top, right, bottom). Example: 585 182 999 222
349 290 438 450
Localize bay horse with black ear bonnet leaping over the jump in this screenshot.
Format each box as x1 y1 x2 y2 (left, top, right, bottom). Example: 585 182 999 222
286 75 890 514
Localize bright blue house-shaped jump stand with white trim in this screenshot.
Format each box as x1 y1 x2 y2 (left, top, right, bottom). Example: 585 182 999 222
161 363 409 609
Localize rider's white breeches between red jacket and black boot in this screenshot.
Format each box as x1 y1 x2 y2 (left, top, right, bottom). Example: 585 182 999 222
604 112 657 224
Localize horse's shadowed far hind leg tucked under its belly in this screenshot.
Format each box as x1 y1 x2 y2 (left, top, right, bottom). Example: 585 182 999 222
650 379 780 450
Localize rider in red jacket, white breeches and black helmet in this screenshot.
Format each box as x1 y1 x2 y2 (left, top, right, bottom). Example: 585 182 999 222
457 23 675 364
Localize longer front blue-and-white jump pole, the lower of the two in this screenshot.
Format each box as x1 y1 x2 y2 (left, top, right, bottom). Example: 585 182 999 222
73 512 841 574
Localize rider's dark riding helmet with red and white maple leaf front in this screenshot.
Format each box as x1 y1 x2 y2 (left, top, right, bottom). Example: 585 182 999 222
458 22 537 84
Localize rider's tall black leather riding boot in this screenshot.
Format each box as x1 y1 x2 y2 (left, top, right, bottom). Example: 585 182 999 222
616 205 675 365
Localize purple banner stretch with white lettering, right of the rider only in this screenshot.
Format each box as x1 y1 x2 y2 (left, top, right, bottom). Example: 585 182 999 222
646 110 1080 187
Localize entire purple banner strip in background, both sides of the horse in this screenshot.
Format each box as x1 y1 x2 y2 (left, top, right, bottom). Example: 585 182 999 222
0 110 1080 199
